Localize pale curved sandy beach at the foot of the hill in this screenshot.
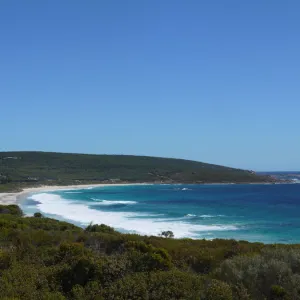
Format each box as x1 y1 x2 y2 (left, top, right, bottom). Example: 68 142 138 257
0 183 143 205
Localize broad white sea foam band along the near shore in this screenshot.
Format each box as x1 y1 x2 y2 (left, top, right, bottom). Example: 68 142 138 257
31 193 237 238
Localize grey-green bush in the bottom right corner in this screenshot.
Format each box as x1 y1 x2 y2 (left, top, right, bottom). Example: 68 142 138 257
216 249 300 300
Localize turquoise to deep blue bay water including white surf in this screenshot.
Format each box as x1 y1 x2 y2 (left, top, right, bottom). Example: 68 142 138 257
22 184 300 243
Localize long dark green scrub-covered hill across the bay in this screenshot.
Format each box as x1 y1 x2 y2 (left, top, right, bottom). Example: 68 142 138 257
0 152 270 191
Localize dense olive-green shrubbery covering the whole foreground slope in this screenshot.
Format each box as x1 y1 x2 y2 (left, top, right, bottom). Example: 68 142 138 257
0 206 300 300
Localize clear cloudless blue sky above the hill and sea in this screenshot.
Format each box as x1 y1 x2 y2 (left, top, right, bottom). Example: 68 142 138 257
0 0 300 170
